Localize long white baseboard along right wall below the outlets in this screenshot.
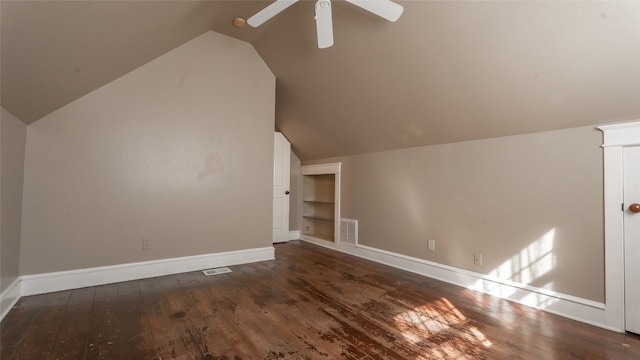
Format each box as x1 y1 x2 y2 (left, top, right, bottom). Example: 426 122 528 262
302 235 624 332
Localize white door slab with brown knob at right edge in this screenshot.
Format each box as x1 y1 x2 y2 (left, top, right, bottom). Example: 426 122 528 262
623 146 640 334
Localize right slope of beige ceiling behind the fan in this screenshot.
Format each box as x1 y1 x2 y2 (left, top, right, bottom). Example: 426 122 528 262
255 1 640 159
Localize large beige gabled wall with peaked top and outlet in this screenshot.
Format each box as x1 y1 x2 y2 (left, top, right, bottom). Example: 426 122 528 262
20 32 275 275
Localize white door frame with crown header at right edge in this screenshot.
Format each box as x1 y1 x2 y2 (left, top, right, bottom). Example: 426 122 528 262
598 120 640 332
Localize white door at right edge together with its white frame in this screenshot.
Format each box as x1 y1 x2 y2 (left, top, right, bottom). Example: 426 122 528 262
598 120 640 332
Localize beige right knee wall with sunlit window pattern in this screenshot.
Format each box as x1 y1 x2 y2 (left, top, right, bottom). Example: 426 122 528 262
304 127 604 302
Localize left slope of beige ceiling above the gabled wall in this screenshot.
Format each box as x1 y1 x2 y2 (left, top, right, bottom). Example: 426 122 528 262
0 1 260 123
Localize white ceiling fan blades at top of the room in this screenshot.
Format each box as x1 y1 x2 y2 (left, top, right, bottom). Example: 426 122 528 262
247 0 404 49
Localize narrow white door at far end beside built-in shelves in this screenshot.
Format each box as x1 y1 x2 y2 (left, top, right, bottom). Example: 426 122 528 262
273 132 291 243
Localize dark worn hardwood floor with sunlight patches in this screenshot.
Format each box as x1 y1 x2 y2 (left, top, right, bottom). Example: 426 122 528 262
0 242 640 360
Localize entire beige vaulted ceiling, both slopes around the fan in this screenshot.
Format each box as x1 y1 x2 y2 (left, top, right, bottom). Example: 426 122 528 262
0 0 640 160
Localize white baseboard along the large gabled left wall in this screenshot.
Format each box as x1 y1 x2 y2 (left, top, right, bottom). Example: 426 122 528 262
21 247 275 296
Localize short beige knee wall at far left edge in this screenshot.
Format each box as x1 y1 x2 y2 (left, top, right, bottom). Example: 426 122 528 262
0 109 27 293
